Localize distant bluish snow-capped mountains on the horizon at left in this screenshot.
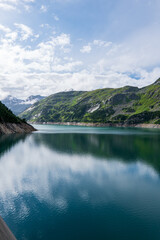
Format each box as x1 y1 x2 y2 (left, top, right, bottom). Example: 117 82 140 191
2 95 44 115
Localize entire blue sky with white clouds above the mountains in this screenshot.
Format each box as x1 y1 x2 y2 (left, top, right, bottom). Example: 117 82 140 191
0 0 160 99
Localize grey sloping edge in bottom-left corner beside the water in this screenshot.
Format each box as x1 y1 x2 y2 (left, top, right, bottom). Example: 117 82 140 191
0 217 16 240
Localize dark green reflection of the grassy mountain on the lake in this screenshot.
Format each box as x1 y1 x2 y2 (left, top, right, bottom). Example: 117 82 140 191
34 132 160 172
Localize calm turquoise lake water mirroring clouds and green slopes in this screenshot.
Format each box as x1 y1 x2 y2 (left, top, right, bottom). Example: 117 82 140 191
0 125 160 240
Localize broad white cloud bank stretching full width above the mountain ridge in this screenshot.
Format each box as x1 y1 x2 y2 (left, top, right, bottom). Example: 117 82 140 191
0 24 160 98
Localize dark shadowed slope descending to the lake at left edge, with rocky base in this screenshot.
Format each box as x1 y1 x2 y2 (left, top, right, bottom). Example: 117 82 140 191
0 102 35 134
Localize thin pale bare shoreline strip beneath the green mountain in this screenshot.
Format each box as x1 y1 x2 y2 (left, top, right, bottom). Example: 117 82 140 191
29 122 160 129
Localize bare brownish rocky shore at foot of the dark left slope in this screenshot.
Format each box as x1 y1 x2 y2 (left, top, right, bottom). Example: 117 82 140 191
0 122 36 134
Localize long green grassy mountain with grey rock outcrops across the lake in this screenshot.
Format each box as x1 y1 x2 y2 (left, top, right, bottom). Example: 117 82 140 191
20 79 160 125
